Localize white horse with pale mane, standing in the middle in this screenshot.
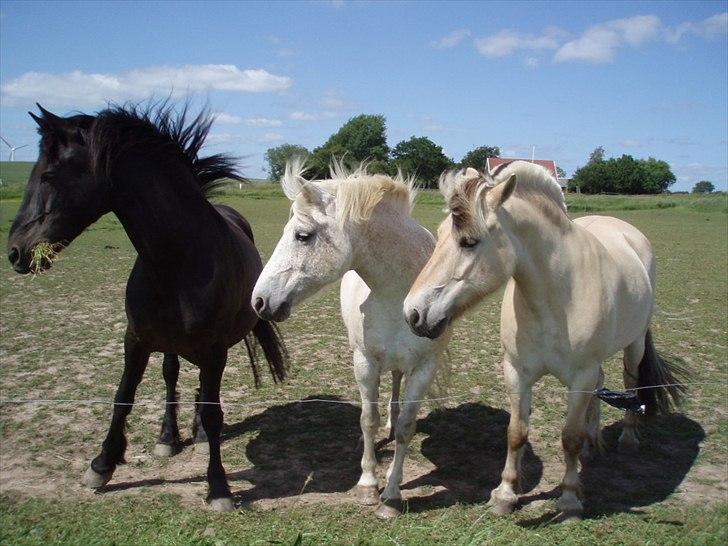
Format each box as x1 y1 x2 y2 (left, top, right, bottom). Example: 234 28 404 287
252 160 450 518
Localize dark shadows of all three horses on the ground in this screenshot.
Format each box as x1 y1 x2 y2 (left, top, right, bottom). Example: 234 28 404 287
104 395 705 516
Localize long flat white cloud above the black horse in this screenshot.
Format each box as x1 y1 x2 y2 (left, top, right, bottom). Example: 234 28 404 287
1 64 293 107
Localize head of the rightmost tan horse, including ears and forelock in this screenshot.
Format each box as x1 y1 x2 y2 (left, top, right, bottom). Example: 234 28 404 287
404 168 516 339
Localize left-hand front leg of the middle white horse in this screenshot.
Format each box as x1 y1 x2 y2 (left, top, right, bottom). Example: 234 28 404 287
354 350 379 505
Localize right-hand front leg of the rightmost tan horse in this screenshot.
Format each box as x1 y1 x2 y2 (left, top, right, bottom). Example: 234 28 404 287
558 364 601 521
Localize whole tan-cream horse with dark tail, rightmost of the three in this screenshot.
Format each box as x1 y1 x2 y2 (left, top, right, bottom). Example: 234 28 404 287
404 162 681 519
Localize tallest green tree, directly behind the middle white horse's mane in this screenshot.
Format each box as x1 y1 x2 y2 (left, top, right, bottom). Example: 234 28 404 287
308 114 389 178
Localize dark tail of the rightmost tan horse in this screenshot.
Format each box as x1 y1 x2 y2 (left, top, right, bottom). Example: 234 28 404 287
637 330 687 415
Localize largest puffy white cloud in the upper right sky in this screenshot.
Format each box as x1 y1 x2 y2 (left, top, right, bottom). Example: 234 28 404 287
554 15 661 63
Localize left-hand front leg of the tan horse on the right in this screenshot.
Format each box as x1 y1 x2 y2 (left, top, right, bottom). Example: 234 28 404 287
488 360 532 515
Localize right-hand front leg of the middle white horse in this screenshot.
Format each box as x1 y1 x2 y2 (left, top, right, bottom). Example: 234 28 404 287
375 358 437 519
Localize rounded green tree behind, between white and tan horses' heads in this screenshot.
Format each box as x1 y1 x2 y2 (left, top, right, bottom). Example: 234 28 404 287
392 136 455 188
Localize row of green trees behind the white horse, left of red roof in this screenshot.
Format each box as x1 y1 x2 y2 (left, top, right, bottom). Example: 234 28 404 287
265 114 500 188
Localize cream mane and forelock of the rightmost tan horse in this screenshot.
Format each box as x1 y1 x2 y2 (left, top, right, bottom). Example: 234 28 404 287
440 161 567 229
